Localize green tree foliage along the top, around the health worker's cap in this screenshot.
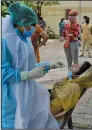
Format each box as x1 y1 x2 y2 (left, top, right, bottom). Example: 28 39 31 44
1 0 59 18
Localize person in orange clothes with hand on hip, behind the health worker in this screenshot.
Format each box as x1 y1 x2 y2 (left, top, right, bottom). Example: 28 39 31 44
31 24 49 63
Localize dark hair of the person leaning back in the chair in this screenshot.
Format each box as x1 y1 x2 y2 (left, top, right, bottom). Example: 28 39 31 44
75 61 92 75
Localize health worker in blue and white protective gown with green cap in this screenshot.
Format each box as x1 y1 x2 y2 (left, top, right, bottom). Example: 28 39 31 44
2 2 62 129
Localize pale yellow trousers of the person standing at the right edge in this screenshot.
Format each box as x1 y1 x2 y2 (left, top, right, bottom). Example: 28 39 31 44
82 39 91 55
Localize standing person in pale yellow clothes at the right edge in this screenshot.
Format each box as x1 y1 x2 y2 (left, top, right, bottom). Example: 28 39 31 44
80 17 92 58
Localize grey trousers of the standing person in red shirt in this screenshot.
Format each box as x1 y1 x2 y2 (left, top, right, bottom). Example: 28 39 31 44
64 41 79 69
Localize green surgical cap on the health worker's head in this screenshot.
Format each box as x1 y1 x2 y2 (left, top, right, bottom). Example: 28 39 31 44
8 2 37 26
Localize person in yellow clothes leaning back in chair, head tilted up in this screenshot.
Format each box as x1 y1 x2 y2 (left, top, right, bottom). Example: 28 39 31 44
50 61 92 116
